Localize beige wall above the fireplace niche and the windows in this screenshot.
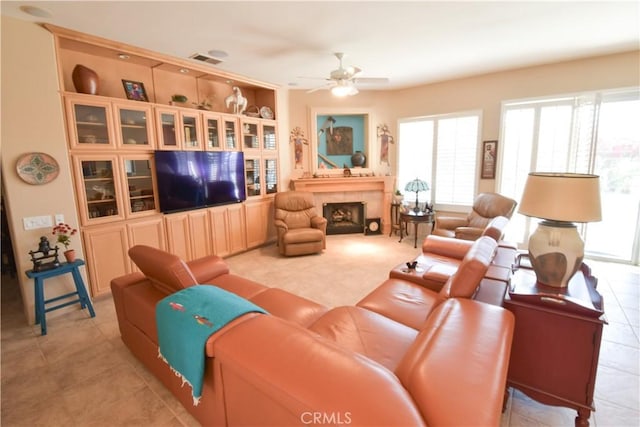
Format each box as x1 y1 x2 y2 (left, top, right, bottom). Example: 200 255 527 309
290 51 640 191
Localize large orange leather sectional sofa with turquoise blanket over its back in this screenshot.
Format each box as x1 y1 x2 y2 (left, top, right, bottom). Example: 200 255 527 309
111 242 513 426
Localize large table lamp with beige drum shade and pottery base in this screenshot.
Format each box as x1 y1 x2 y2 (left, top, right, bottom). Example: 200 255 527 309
518 172 602 288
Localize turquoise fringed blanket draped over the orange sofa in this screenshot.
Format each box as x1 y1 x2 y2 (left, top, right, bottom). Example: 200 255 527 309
156 285 266 405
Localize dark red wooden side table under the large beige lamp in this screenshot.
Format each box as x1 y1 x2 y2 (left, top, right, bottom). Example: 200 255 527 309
504 264 607 427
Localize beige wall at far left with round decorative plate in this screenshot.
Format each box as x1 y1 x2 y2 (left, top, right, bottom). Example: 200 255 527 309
0 16 86 322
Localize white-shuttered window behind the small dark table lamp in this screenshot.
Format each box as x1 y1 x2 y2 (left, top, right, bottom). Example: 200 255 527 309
398 112 480 211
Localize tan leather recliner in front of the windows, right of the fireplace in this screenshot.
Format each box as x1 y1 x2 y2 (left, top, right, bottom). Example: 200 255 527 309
432 193 518 240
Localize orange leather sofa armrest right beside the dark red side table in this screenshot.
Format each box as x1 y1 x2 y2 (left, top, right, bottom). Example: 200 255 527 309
396 299 514 426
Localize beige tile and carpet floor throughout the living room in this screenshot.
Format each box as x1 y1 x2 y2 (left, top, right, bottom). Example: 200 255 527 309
1 235 640 427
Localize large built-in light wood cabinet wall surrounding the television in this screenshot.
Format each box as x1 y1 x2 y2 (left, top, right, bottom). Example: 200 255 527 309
45 24 278 296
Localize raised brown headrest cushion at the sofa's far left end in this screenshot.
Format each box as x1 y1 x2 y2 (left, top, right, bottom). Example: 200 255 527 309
129 245 198 295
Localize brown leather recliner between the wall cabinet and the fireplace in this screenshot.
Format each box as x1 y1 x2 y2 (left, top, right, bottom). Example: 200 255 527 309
274 191 327 256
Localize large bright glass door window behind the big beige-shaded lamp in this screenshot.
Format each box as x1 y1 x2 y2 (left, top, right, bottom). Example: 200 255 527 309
498 88 640 263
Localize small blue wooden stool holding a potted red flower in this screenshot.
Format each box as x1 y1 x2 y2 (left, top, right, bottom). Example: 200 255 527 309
26 259 96 335
